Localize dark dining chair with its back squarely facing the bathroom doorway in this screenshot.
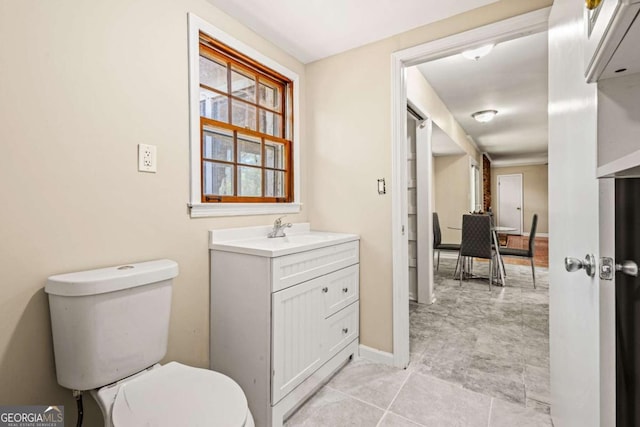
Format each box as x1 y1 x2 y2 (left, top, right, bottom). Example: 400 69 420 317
458 215 495 290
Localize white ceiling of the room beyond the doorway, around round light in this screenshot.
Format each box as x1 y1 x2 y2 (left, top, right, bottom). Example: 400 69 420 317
418 32 548 166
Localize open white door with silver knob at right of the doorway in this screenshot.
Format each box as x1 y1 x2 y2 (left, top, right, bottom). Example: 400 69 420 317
549 0 615 427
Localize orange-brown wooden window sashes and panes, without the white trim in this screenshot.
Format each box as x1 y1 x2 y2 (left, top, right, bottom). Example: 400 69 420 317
199 33 293 203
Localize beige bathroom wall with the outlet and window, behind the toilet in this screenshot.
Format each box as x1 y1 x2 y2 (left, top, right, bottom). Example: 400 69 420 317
0 0 307 426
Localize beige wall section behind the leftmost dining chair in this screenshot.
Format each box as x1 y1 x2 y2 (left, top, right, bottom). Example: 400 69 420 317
433 154 471 243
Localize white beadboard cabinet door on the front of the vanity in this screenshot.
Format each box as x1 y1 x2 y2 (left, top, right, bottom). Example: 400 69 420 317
271 277 326 405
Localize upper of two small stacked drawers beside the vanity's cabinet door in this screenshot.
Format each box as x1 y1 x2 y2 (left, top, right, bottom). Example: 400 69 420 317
322 264 360 317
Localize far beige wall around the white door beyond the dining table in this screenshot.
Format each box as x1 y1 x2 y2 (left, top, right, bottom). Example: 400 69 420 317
491 165 549 233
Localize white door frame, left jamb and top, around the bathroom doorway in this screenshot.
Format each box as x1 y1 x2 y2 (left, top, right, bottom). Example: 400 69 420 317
391 7 551 368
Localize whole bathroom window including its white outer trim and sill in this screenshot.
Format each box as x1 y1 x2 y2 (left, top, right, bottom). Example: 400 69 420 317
189 14 300 216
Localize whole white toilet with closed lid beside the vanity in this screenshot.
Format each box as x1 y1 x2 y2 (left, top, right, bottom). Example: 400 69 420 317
45 259 255 427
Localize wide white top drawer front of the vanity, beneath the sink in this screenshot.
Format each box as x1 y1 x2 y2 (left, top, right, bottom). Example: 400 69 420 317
271 240 360 292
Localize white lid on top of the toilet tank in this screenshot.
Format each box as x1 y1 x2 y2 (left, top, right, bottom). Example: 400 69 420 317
44 259 178 296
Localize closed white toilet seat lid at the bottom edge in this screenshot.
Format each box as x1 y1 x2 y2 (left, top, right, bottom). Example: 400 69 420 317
111 362 251 427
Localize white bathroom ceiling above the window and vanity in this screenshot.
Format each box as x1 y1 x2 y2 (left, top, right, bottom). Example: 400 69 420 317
208 0 497 63
